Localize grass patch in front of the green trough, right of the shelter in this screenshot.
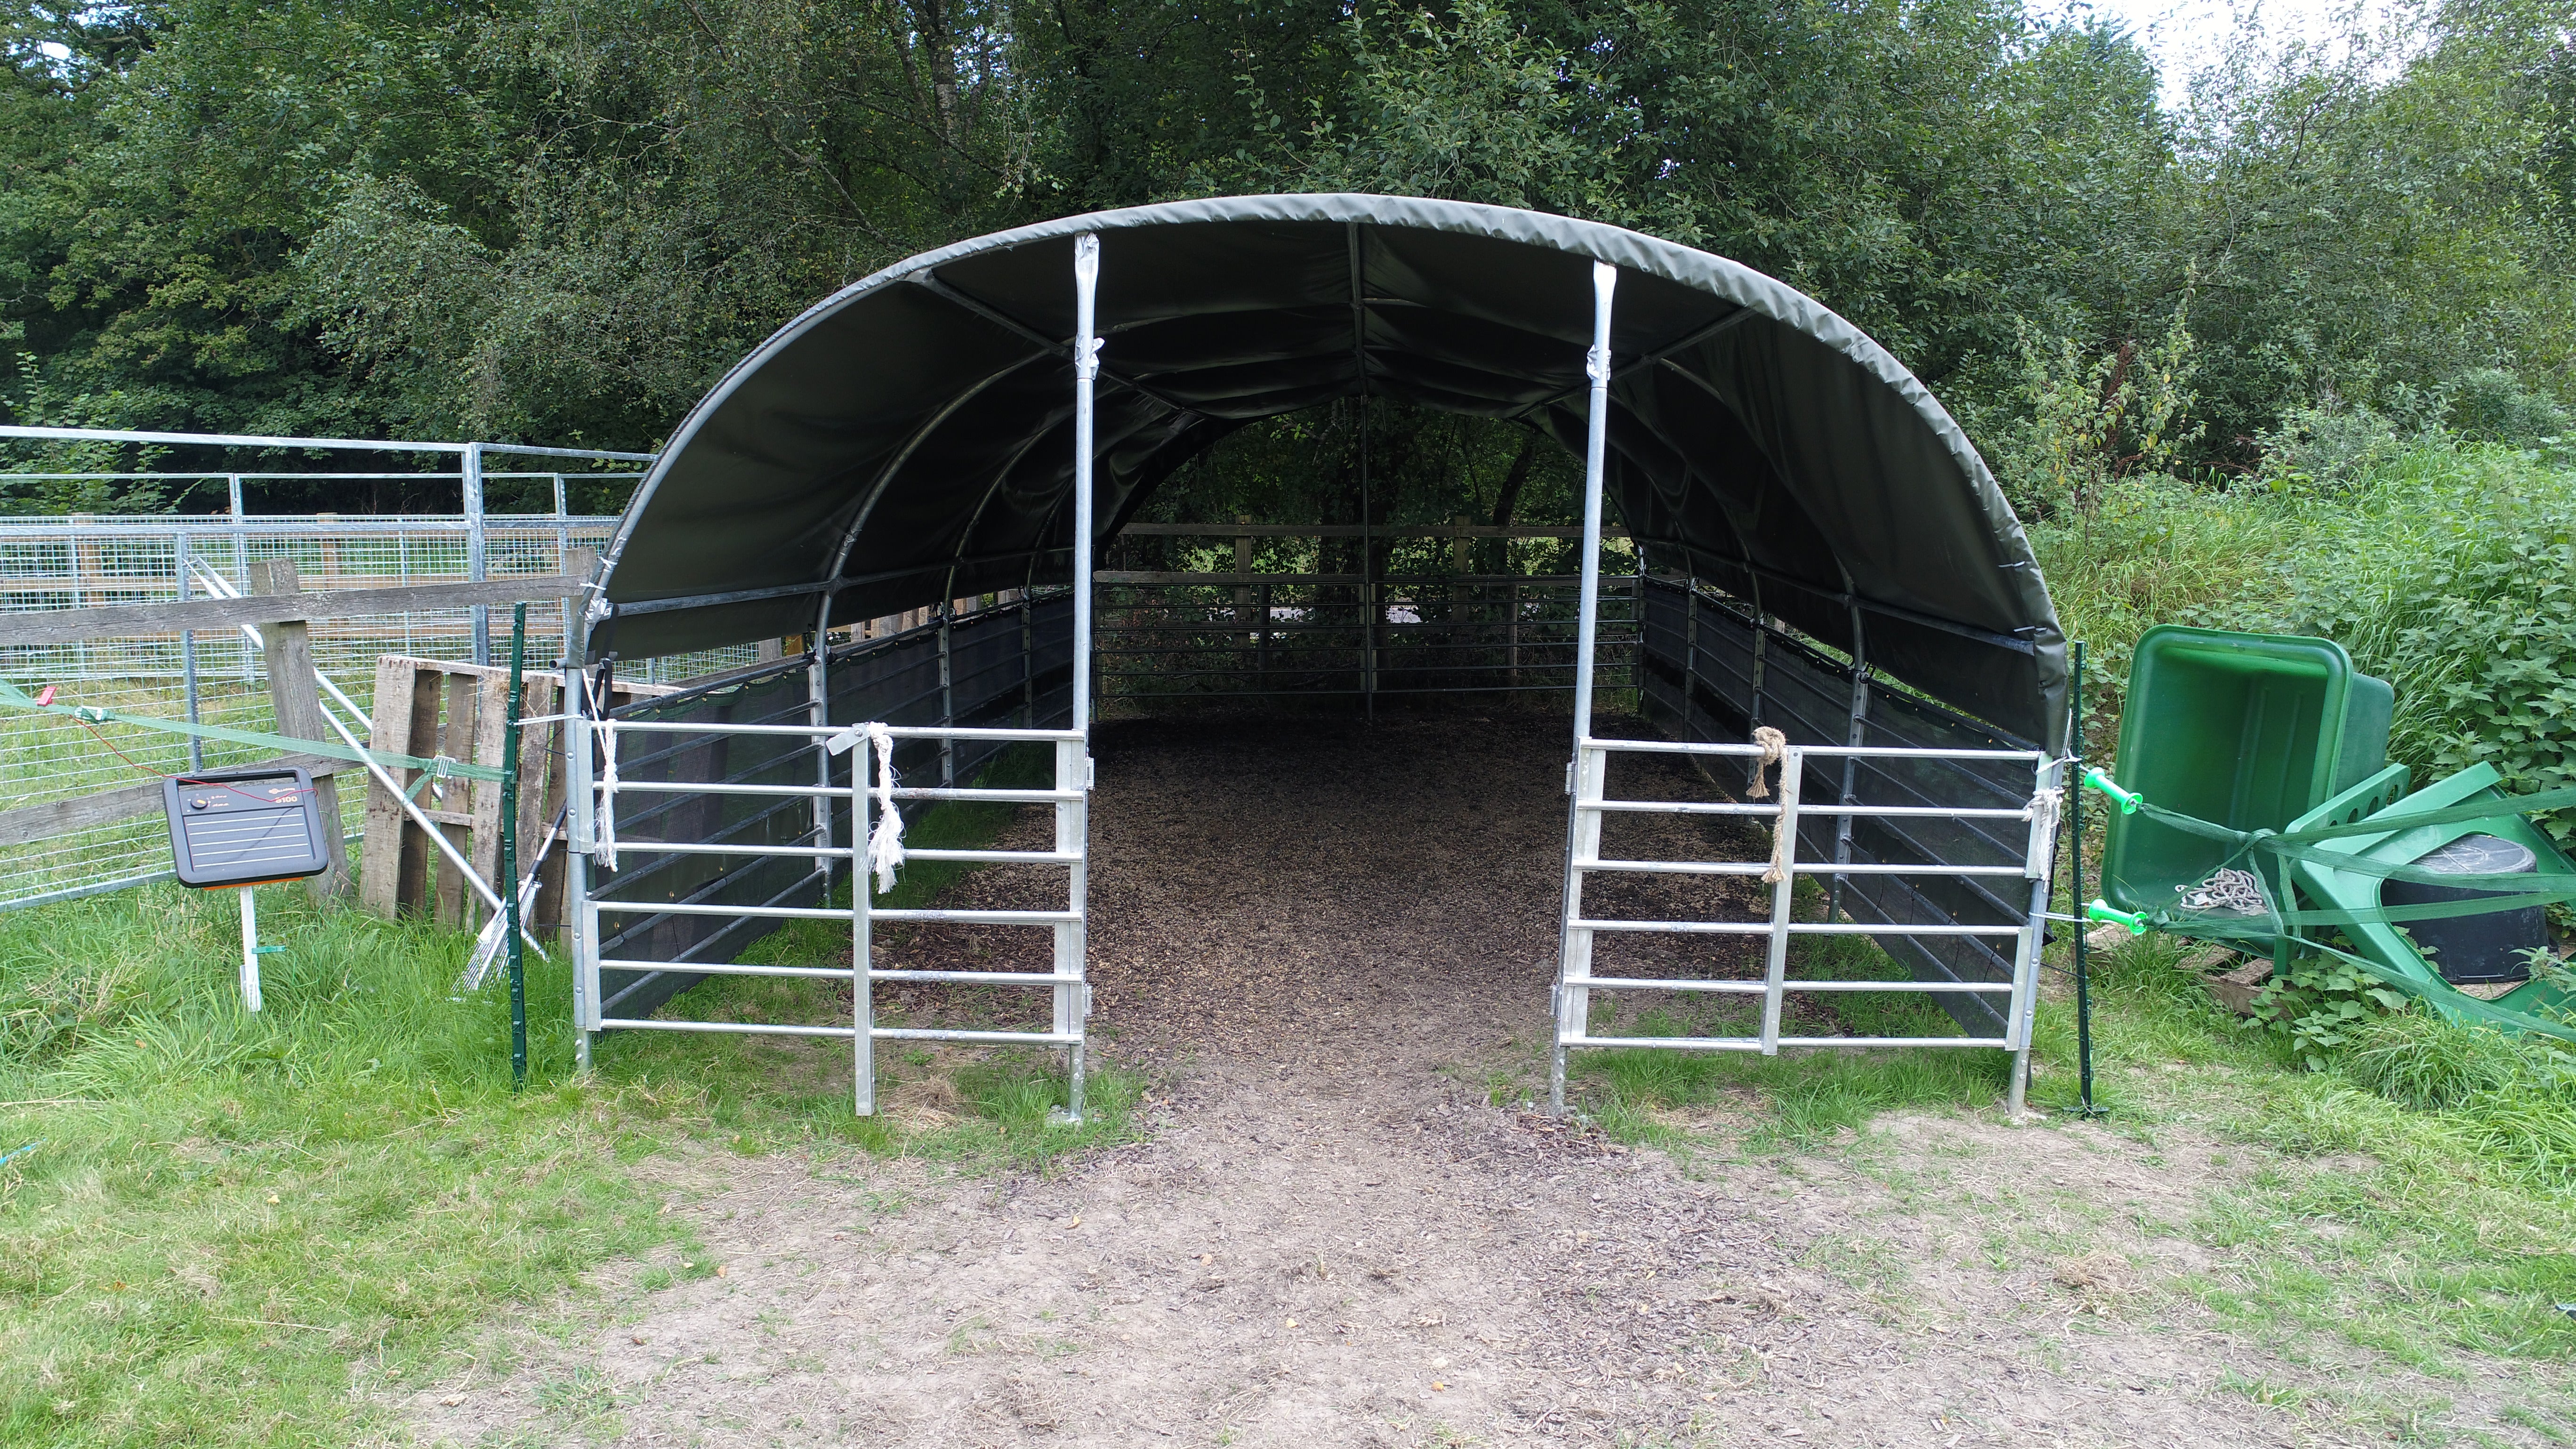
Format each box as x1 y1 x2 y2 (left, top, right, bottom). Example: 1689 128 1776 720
2043 936 2576 1372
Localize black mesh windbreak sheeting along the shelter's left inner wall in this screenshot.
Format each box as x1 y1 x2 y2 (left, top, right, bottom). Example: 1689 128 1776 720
590 593 1074 1018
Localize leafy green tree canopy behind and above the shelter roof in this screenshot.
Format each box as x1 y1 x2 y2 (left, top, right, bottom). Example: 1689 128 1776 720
0 0 2576 515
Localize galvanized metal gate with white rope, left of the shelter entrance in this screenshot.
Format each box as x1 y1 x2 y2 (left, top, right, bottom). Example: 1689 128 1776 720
574 719 1090 1121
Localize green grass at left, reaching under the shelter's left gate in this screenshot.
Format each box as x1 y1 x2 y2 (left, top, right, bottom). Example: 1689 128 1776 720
0 742 1136 1447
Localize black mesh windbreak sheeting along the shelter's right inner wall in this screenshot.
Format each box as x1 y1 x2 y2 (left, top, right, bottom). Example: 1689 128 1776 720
1641 578 2035 1037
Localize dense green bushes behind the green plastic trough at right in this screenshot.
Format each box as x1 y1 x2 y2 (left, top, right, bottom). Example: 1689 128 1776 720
2032 436 2576 838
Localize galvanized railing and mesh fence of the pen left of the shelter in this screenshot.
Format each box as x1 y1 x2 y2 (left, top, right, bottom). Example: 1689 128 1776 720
0 428 752 908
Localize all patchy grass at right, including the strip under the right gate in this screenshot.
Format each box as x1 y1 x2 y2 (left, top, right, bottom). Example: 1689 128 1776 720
1574 866 2576 1395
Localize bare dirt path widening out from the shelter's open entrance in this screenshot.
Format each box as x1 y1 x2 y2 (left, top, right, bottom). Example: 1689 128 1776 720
417 719 2555 1449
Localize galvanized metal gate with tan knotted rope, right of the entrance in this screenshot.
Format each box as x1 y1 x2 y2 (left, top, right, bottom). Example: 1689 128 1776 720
1548 737 2061 1114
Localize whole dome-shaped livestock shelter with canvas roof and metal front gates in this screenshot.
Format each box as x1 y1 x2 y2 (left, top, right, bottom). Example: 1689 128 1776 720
572 196 2066 1109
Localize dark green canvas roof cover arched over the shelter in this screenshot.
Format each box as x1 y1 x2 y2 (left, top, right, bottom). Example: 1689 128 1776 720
603 196 2066 745
